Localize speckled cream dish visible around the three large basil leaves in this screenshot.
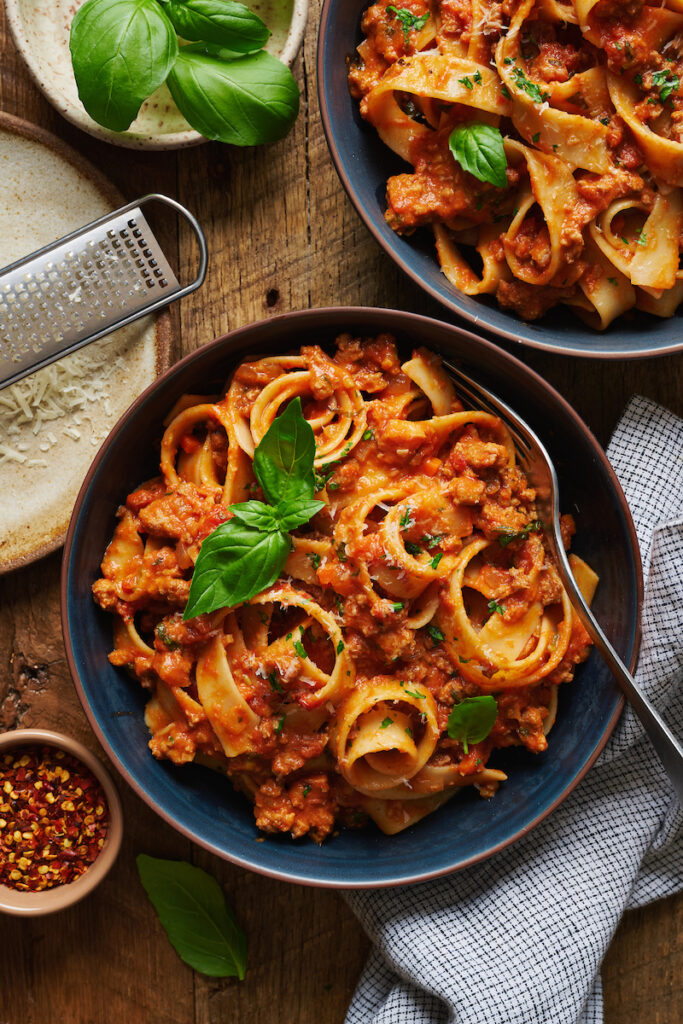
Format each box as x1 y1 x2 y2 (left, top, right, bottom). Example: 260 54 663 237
5 0 308 150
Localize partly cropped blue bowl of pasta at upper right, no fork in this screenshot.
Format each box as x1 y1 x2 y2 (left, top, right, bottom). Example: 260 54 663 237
317 0 683 358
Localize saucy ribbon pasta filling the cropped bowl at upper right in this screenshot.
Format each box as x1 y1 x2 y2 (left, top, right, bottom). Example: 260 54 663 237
349 0 683 330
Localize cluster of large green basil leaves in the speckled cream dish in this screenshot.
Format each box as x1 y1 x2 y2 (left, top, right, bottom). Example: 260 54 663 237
70 0 299 145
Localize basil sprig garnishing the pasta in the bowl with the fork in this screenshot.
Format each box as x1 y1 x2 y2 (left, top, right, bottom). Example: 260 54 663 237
182 398 325 620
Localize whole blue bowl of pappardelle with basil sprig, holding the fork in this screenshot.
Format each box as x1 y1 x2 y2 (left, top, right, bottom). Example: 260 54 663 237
62 308 642 887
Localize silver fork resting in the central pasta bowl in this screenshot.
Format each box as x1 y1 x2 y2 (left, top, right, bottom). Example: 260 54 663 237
443 360 683 804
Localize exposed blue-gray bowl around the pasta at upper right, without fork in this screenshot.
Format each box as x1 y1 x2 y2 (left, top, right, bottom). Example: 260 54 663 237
317 0 683 357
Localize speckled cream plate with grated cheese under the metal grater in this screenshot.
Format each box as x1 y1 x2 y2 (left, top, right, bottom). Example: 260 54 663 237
0 114 170 572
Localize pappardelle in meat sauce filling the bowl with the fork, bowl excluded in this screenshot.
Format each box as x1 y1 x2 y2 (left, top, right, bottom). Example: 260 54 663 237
93 335 597 842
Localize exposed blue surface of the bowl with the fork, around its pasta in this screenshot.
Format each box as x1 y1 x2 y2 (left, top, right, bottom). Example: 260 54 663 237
61 308 642 887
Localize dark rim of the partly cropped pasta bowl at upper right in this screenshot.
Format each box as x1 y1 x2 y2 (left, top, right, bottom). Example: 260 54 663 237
316 0 683 359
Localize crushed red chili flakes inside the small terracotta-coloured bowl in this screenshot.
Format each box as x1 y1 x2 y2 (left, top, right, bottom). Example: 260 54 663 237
0 745 109 892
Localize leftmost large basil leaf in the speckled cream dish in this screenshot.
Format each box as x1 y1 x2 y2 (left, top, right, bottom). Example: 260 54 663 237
69 0 178 131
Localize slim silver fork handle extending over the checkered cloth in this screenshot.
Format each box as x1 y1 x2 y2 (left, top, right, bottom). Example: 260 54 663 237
560 565 683 805
